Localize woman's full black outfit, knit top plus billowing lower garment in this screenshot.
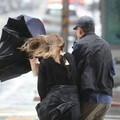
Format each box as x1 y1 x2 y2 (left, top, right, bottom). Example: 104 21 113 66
36 53 81 120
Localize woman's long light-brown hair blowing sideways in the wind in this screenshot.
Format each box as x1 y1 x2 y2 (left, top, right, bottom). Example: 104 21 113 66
20 34 64 63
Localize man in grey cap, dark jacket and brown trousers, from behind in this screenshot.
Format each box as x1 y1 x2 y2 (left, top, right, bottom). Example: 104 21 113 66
72 16 115 120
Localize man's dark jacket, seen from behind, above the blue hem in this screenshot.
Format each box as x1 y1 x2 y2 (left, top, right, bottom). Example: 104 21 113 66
73 33 114 96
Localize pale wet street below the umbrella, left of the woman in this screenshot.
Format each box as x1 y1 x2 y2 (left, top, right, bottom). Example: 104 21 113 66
0 72 39 120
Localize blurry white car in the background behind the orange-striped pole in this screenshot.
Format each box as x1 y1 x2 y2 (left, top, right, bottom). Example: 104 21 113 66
42 4 78 36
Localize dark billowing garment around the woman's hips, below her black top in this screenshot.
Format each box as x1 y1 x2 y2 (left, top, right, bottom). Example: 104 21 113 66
36 85 81 120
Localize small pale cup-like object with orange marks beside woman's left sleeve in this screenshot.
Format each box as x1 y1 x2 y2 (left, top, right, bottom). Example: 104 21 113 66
29 58 40 77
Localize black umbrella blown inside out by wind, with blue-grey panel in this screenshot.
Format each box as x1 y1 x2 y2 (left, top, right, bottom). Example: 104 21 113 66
0 15 46 81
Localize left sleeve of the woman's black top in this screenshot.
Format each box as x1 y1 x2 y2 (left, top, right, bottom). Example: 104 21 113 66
37 60 47 100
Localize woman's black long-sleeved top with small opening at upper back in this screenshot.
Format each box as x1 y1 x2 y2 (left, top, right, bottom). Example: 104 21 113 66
37 52 77 100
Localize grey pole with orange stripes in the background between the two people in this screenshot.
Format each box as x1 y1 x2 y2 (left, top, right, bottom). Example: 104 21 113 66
61 0 69 51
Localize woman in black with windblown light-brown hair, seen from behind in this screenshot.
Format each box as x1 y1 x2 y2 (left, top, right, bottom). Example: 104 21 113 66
22 34 80 120
